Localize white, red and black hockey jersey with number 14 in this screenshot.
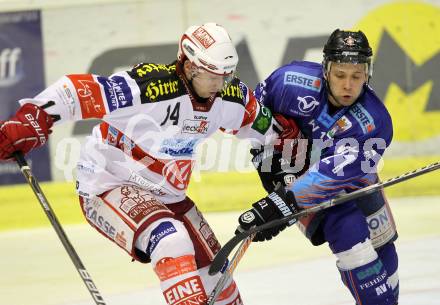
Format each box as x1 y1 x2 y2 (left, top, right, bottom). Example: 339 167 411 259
20 63 278 203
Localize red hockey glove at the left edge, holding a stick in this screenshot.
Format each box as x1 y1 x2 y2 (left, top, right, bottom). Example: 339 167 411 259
0 104 53 160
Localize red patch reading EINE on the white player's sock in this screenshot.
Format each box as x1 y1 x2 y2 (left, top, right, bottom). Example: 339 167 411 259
163 276 207 305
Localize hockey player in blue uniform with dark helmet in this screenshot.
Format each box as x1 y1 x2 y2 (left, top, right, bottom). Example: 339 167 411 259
239 29 399 305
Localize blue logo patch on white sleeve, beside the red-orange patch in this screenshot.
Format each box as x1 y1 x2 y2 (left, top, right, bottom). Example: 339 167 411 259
97 76 133 112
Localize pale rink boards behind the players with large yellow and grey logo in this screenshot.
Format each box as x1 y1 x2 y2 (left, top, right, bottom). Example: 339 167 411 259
0 0 440 184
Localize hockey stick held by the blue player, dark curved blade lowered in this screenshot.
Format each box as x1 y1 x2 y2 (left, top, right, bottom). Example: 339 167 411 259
209 162 440 275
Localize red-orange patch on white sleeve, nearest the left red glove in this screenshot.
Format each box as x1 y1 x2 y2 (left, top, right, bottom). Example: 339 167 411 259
67 74 106 119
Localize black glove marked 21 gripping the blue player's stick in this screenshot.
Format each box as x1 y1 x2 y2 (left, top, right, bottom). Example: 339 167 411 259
235 184 299 241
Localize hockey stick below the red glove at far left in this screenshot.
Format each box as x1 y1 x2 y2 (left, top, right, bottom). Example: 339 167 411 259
13 152 105 305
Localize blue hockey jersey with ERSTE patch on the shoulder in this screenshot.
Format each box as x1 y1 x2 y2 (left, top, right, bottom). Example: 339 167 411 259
255 61 393 208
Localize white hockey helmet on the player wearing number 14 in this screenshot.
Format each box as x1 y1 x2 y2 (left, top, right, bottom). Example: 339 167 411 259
177 22 238 75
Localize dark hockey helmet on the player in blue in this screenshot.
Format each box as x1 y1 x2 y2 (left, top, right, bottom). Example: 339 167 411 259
322 29 373 77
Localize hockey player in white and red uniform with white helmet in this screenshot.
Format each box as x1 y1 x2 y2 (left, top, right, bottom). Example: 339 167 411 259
0 23 298 305
